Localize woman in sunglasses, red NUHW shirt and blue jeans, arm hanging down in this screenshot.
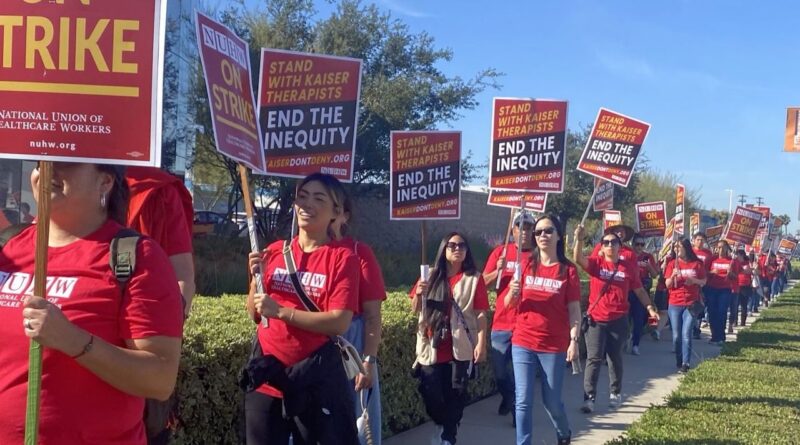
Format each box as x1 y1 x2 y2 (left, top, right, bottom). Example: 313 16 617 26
505 215 581 445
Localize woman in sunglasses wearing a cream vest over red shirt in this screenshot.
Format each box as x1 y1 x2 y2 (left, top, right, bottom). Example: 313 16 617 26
410 232 489 445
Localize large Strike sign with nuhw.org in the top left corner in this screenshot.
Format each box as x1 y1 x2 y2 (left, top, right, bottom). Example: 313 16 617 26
0 0 166 166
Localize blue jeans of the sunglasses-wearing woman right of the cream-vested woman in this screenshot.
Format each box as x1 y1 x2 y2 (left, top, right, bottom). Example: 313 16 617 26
511 345 572 445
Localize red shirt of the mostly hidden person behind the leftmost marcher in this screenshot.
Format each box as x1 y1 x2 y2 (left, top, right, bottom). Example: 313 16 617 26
125 167 194 256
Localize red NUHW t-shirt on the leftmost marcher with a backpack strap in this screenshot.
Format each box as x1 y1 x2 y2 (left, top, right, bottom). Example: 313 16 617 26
0 220 183 445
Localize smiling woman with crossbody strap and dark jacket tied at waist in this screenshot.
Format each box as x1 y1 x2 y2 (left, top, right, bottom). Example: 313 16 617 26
245 173 359 445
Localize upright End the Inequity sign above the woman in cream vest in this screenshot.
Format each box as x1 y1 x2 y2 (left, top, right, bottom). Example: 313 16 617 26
389 131 461 220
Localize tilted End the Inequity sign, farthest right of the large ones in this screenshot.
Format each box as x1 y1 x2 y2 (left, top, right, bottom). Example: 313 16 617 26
578 108 650 187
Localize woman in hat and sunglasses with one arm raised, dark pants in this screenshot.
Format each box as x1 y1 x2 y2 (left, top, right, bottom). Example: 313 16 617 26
573 225 658 413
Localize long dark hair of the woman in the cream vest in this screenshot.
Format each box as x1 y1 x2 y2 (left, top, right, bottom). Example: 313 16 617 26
425 232 478 329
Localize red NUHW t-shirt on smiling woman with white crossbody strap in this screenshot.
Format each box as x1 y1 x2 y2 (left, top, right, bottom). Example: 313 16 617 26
258 237 359 397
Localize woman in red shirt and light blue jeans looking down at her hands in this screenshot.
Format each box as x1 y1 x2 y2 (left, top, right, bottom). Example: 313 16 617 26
664 238 706 373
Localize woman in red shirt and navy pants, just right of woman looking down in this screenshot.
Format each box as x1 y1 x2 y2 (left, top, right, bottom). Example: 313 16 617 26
706 240 739 345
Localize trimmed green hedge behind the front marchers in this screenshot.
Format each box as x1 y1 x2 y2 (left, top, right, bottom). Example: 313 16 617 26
175 292 495 444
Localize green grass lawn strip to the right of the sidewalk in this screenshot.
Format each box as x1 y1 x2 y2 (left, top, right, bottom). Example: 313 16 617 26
609 280 800 445
